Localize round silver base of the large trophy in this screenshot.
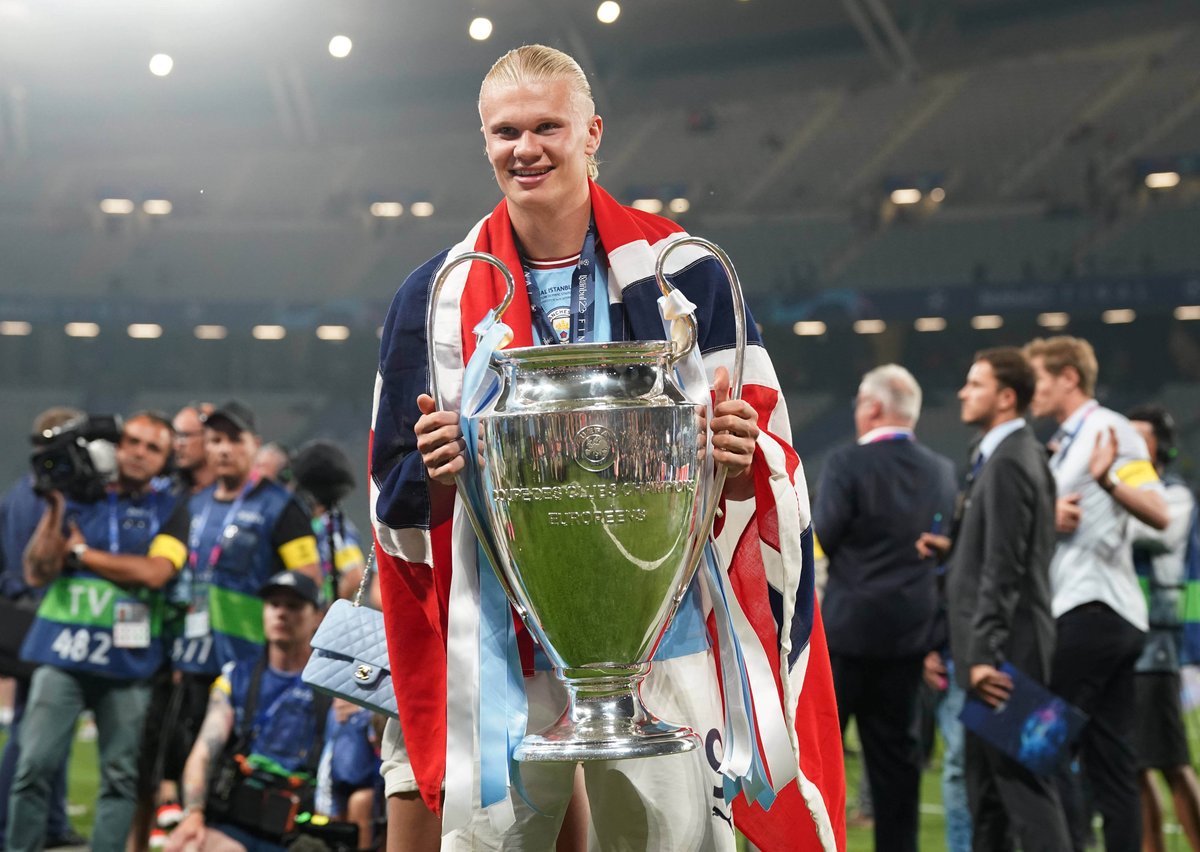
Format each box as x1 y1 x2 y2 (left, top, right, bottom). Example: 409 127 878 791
514 678 700 763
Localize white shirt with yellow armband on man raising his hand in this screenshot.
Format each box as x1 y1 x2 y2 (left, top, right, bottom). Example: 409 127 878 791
1050 400 1163 630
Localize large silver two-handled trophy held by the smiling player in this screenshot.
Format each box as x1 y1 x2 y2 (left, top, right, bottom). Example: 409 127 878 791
426 236 745 762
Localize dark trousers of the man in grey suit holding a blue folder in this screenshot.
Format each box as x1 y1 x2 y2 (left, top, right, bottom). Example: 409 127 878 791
966 731 1070 852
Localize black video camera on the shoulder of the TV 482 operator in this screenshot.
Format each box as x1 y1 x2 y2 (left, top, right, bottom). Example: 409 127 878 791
30 414 121 503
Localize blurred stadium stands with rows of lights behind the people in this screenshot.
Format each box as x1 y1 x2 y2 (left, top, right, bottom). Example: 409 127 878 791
0 0 1200 521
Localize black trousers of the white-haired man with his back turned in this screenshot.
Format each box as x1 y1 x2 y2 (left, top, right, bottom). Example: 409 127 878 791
829 654 923 852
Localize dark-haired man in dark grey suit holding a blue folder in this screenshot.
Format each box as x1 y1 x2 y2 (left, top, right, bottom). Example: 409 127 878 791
918 347 1070 852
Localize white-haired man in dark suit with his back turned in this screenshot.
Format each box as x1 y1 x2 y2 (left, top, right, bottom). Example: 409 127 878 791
812 364 956 852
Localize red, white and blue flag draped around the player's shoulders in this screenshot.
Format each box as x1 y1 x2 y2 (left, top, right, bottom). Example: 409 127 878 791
371 184 845 852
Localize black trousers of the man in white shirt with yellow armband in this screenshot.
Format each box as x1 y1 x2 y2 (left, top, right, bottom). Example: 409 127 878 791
1050 602 1146 852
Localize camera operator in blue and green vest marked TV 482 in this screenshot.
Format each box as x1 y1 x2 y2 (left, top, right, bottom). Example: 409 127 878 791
6 413 188 852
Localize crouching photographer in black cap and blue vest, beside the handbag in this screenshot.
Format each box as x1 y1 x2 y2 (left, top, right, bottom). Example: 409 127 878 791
167 571 343 852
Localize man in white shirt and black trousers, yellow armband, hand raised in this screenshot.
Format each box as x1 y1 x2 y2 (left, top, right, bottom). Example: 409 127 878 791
1025 336 1168 852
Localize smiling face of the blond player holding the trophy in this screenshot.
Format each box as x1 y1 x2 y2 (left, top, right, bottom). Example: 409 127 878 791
479 79 602 222
